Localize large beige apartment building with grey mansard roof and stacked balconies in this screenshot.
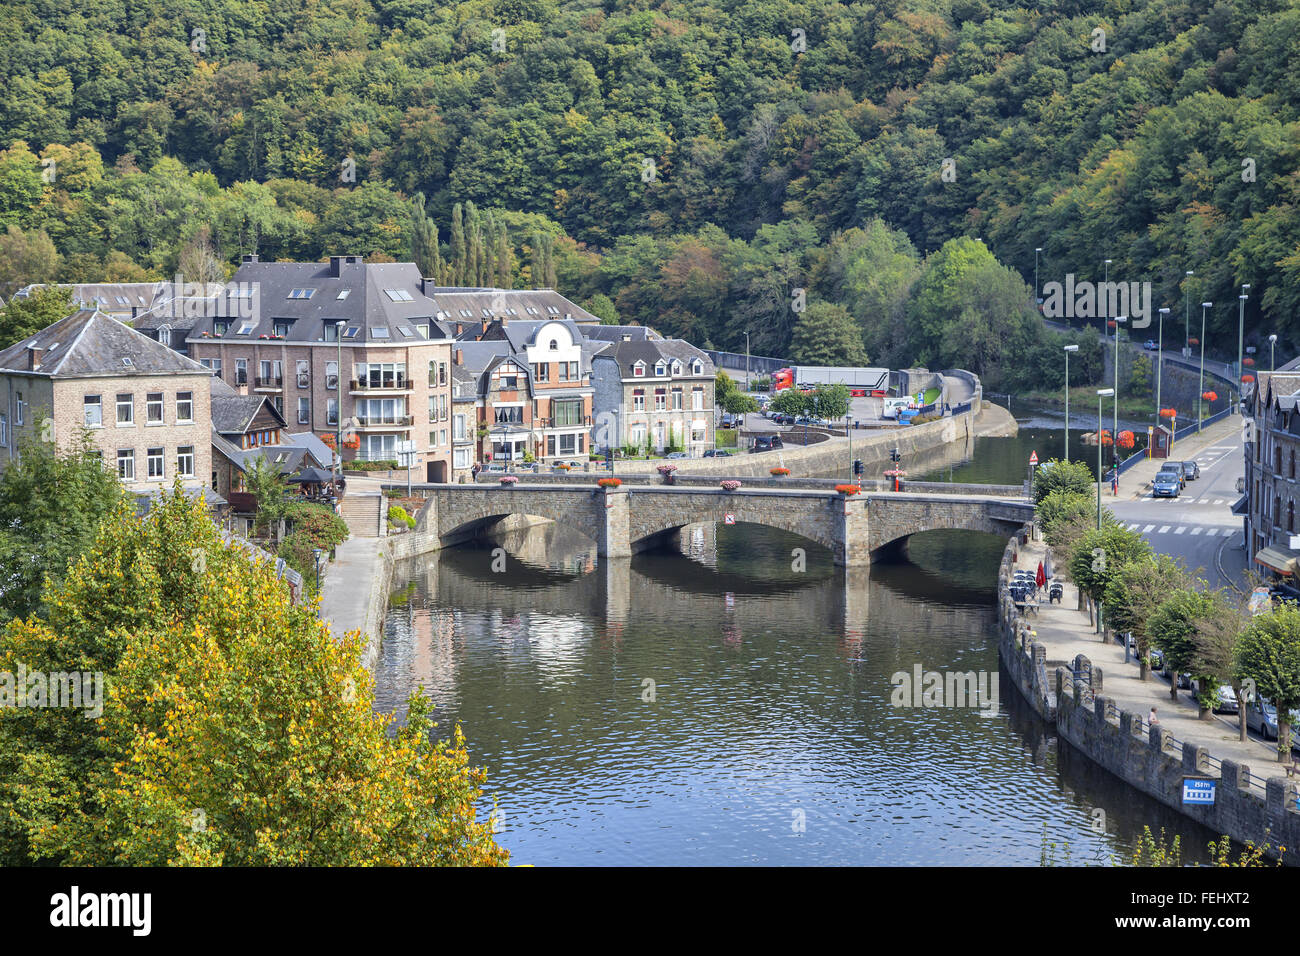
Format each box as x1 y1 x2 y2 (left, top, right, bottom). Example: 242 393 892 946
186 256 452 481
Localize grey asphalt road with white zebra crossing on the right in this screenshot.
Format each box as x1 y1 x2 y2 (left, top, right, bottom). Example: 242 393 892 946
1102 418 1245 589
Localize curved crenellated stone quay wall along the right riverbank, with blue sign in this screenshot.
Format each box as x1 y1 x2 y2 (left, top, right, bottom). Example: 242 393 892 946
997 524 1300 864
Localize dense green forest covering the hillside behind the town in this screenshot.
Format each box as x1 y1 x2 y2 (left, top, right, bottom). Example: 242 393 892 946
0 0 1300 386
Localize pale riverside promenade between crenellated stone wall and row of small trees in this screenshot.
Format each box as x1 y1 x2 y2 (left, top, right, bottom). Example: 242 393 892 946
1015 538 1283 792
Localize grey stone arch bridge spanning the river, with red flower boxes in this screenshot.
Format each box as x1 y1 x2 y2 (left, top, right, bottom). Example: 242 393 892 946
417 483 1034 567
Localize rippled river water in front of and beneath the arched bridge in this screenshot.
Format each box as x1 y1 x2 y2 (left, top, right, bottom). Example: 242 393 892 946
376 524 1208 865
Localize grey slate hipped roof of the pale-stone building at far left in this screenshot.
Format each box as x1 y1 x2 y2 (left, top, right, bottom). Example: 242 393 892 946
0 308 211 377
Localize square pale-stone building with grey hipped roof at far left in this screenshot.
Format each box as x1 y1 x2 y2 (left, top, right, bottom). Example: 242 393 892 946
0 310 212 494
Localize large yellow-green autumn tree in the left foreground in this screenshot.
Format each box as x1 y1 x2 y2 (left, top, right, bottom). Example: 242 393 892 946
0 489 507 866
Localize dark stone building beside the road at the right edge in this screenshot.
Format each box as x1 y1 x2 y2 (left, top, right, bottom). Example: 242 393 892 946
1234 371 1300 587
